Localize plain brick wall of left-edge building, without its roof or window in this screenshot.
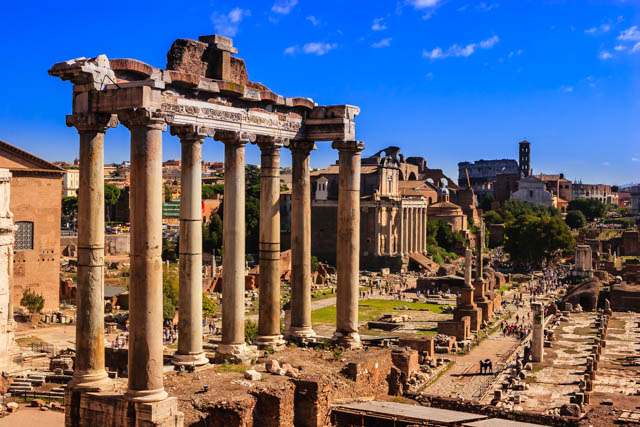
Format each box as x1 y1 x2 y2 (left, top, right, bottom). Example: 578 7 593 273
10 175 62 311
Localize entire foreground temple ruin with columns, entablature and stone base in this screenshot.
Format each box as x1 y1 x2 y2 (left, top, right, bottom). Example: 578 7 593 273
49 35 364 425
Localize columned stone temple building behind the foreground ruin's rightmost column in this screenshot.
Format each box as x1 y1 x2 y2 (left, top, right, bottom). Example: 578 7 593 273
312 147 435 270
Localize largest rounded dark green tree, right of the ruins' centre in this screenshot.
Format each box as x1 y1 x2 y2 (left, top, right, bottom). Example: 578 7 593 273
504 214 575 267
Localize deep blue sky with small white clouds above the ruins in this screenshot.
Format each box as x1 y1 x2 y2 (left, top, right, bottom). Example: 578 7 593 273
0 0 640 184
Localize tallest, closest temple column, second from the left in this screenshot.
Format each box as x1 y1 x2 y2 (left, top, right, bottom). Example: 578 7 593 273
118 108 167 402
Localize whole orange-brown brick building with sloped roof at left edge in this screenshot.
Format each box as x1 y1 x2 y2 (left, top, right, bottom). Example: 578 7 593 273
0 141 65 310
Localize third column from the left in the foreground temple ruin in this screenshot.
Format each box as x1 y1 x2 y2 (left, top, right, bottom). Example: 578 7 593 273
171 125 213 366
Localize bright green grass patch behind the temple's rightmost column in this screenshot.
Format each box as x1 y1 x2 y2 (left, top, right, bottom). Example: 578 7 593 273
311 299 442 324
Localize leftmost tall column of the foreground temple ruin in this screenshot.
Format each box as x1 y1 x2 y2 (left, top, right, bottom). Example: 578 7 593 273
67 113 118 390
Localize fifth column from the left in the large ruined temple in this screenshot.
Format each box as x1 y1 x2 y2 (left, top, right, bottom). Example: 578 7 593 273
256 137 284 348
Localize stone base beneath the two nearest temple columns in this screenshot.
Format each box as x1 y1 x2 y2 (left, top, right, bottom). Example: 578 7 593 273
64 390 184 427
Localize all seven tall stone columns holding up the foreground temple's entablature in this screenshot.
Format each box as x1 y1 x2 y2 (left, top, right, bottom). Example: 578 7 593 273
67 109 364 402
